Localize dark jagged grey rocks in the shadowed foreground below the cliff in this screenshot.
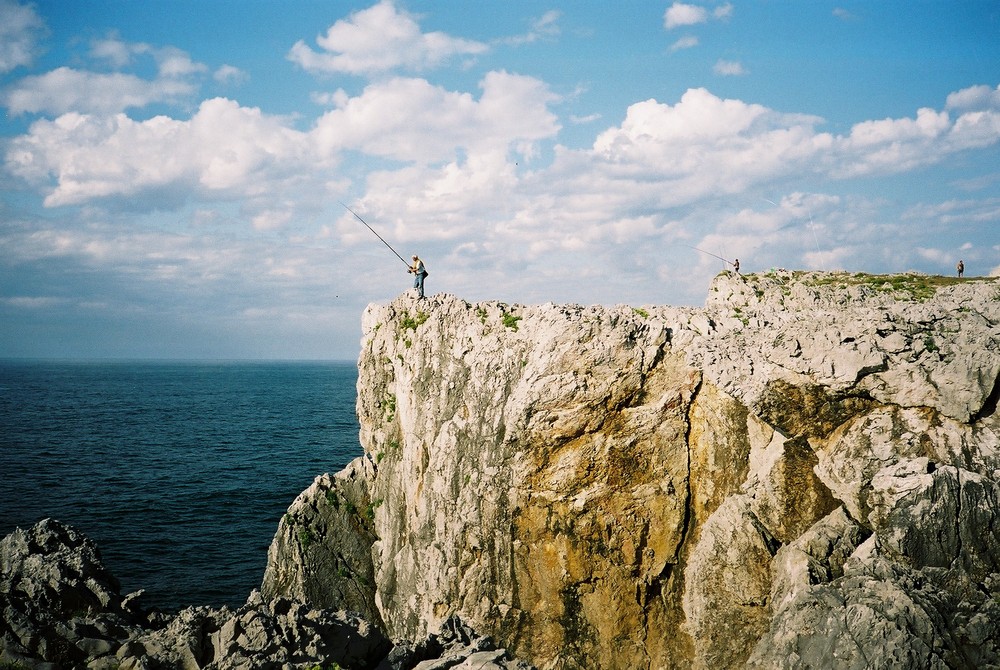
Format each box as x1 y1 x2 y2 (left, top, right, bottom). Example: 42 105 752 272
0 519 530 670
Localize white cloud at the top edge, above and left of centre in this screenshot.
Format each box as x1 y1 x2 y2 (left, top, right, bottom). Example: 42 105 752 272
288 0 488 75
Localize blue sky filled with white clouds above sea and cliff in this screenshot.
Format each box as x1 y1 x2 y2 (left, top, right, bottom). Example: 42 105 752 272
0 0 1000 359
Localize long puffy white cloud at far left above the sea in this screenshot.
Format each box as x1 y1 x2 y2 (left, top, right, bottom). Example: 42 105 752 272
6 98 305 206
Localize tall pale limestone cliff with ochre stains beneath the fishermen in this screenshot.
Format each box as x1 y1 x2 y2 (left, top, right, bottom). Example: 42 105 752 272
263 272 1000 668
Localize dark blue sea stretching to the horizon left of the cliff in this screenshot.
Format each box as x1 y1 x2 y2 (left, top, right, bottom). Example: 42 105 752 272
0 361 361 610
